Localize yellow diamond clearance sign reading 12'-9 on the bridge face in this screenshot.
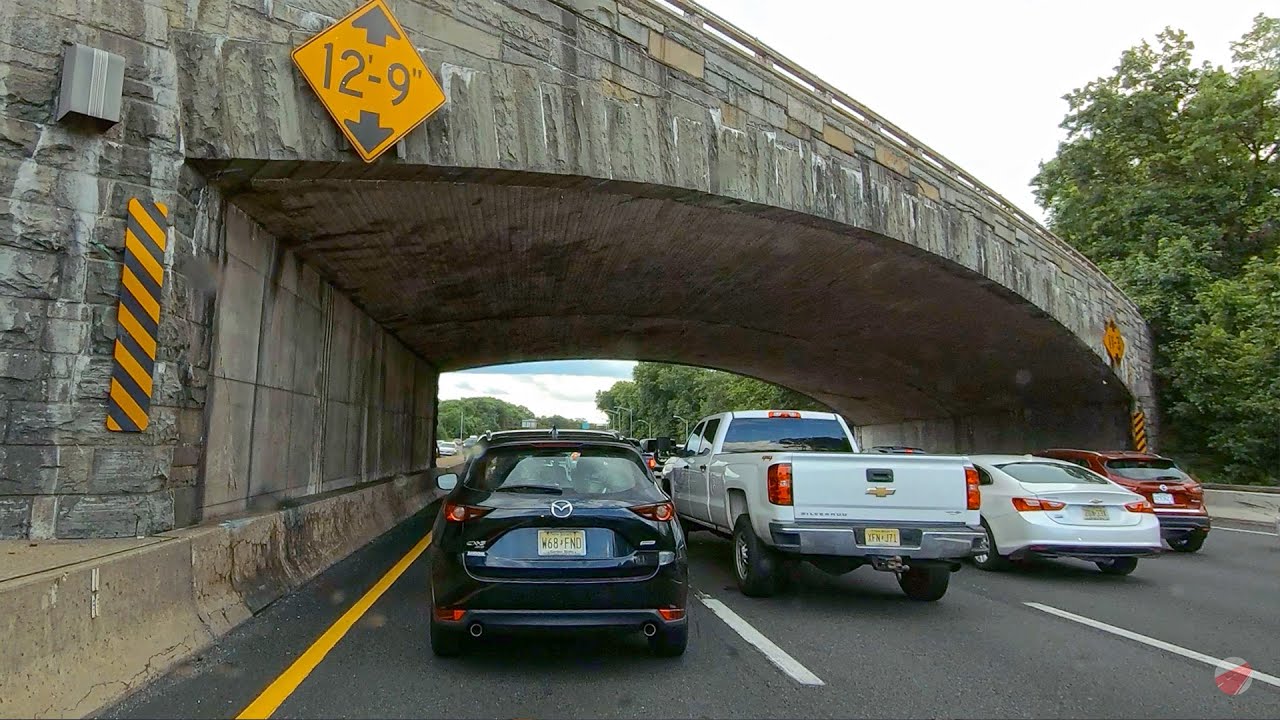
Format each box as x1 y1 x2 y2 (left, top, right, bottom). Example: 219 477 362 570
293 0 444 163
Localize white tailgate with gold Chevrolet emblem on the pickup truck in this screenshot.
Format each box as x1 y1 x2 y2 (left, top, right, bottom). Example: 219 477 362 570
790 454 977 523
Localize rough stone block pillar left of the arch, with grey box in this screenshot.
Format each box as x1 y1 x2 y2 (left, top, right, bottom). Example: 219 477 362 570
0 0 202 538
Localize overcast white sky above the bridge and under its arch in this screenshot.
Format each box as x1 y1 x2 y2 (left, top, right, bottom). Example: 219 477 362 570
440 0 1280 421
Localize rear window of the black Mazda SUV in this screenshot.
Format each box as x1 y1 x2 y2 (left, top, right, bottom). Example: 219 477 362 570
463 445 664 502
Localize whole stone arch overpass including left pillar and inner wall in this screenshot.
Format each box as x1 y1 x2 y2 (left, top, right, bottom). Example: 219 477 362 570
0 0 1156 537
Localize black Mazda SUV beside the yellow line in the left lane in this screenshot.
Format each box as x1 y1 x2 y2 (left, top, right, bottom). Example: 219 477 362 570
428 429 689 656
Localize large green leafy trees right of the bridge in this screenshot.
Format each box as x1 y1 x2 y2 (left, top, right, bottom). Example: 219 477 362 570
1033 15 1280 477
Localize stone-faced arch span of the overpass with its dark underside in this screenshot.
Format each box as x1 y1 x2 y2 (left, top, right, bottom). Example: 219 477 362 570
173 0 1155 433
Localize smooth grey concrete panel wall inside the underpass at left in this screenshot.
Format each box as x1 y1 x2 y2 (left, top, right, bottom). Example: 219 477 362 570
198 206 436 518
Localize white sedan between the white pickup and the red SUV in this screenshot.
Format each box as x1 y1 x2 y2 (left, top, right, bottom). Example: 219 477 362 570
970 455 1161 575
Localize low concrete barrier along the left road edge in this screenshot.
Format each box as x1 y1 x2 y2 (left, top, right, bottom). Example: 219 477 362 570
0 473 442 717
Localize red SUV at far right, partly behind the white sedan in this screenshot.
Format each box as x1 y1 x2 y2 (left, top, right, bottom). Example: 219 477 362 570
1036 450 1210 552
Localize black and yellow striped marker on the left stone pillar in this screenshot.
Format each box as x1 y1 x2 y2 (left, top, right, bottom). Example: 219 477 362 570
106 197 169 433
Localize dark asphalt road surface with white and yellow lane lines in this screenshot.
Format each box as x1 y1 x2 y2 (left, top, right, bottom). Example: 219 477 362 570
102 507 1280 717
